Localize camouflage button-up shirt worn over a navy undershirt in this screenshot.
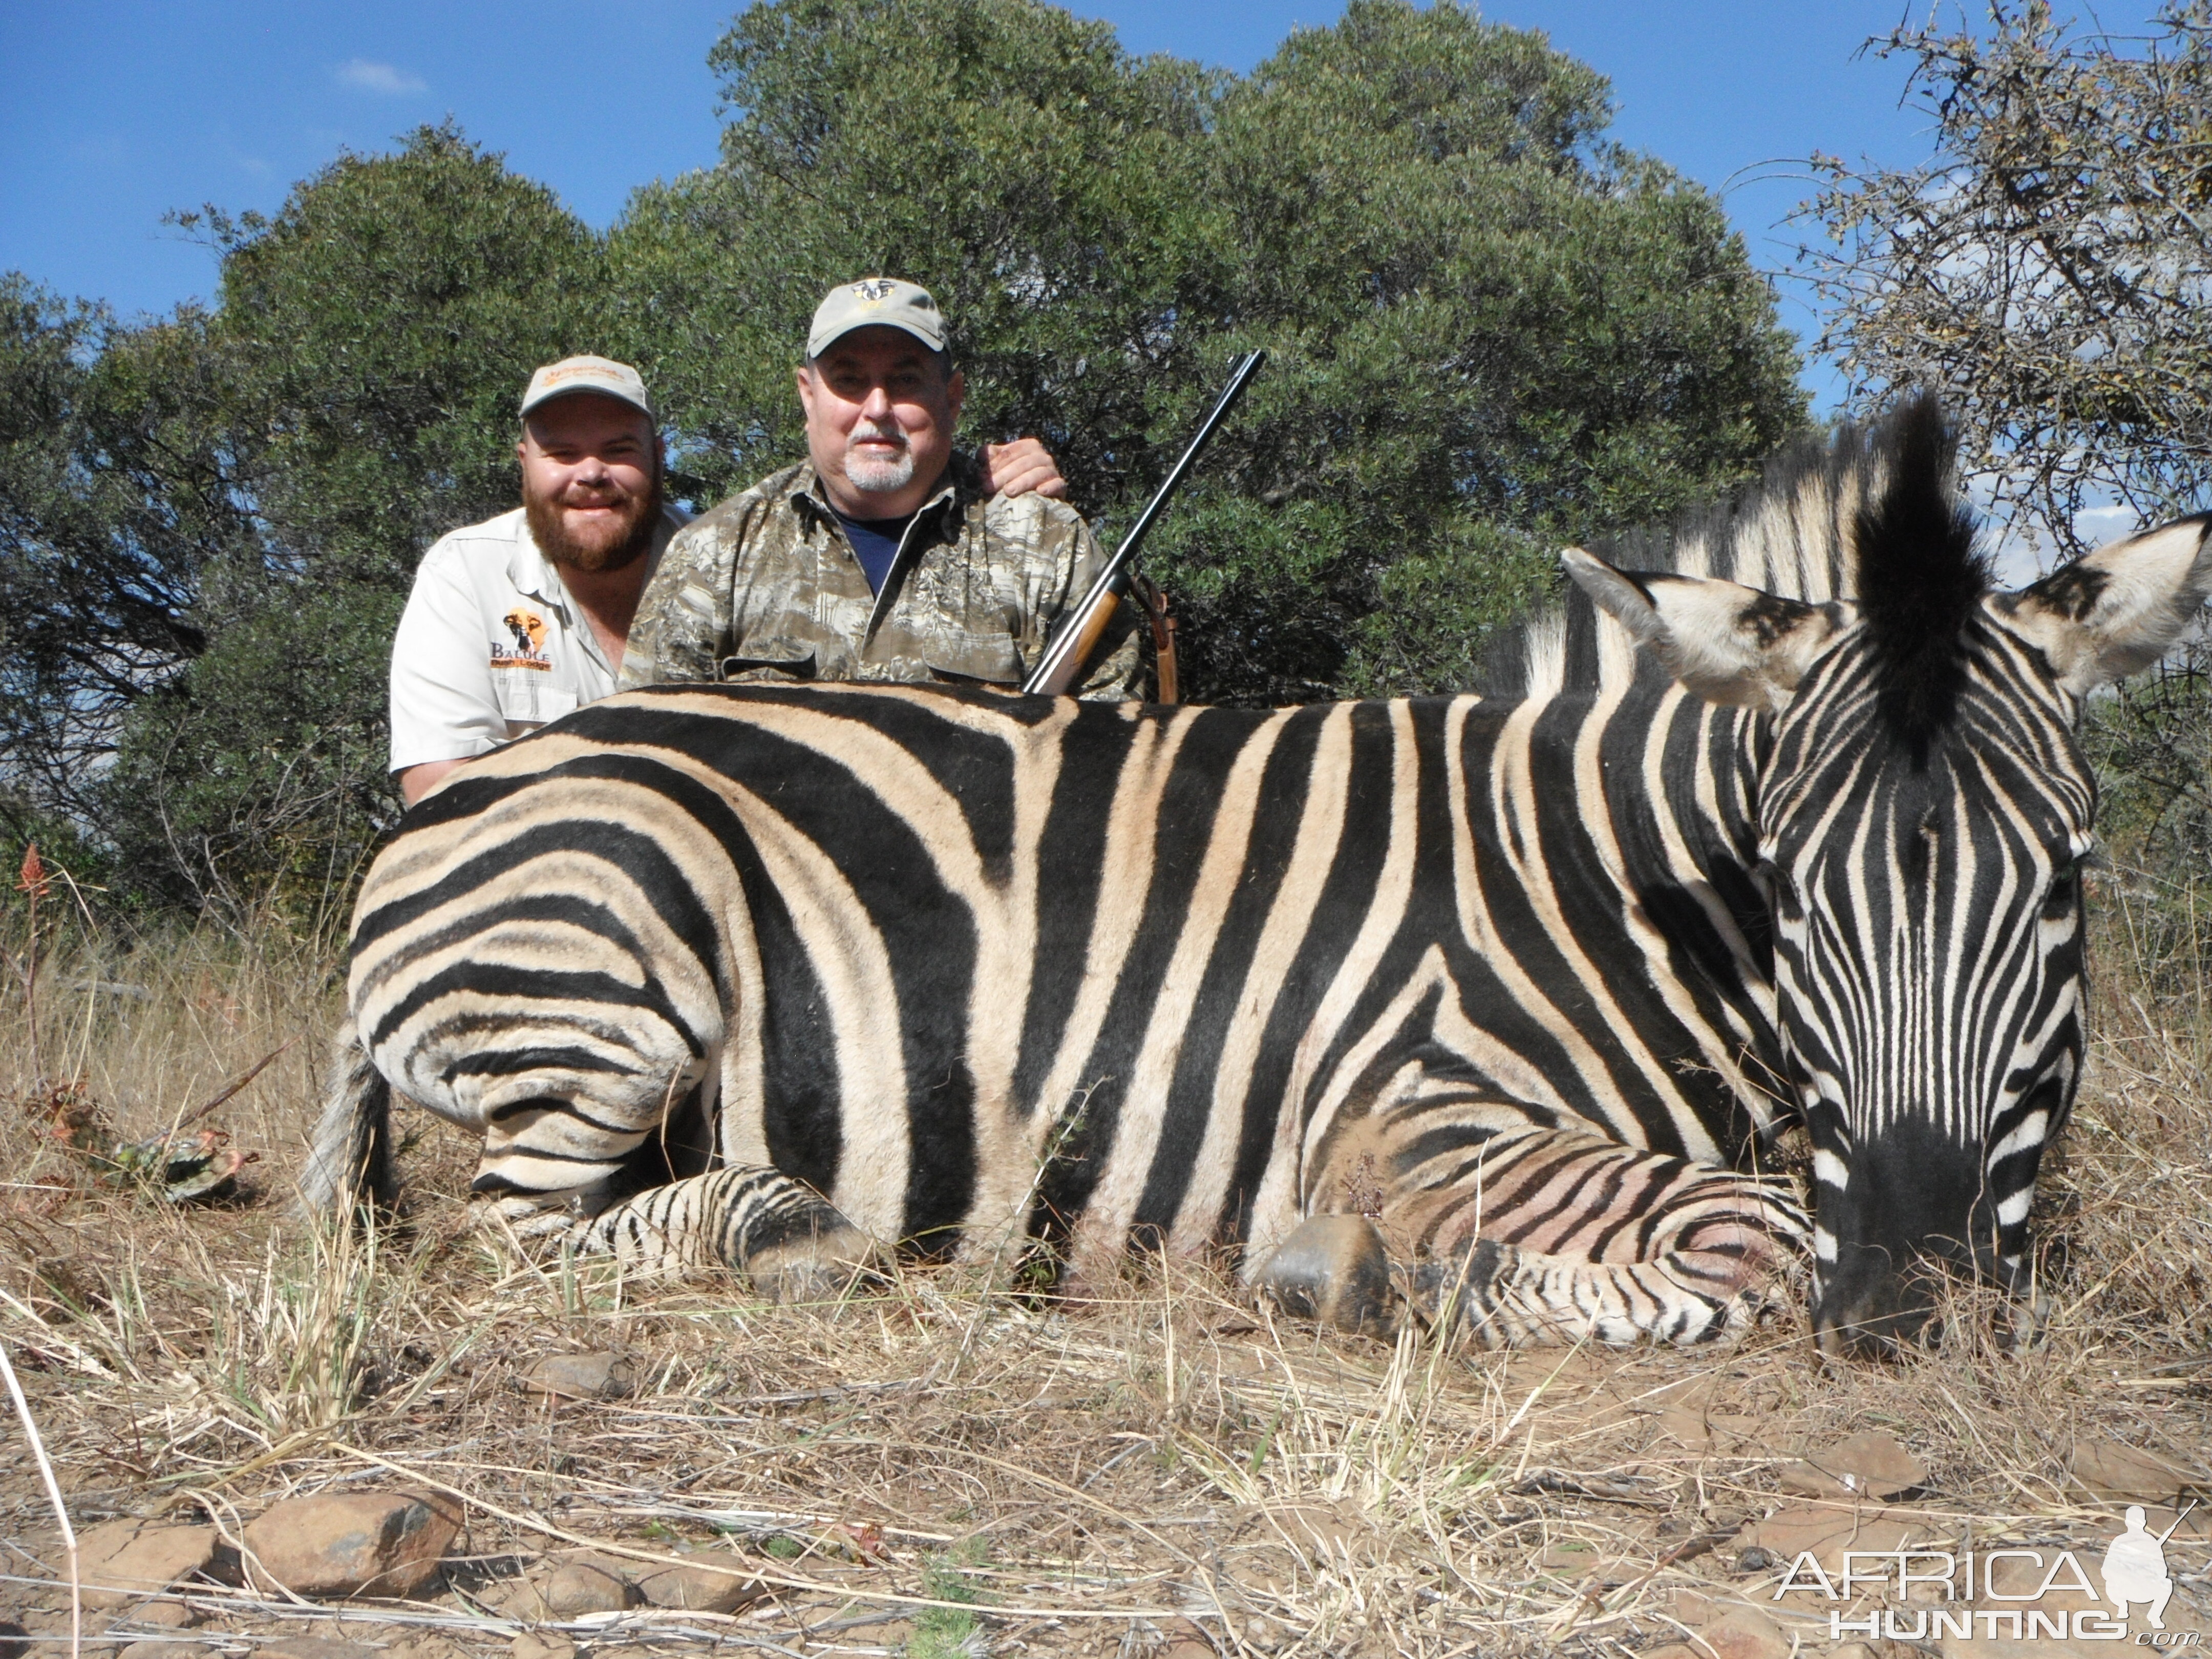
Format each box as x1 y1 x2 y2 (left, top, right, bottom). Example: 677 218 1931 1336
622 456 1146 699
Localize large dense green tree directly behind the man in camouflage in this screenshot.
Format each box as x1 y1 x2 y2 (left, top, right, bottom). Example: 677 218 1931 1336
628 0 1805 701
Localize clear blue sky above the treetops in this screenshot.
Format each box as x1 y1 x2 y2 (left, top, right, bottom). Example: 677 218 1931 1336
0 0 2148 411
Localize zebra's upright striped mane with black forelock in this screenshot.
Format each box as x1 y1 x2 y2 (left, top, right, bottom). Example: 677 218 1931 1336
1475 394 1989 708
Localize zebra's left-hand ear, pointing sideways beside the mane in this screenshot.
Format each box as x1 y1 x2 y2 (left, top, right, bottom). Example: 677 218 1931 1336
1560 546 1852 708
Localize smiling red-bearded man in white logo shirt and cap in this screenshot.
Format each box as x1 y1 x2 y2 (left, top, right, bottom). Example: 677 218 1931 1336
392 356 1066 805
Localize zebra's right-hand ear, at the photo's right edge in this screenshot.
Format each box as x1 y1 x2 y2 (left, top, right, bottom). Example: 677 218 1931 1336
1991 513 2212 697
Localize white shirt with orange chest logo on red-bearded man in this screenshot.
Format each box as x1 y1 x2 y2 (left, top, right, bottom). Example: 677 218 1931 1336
392 506 686 772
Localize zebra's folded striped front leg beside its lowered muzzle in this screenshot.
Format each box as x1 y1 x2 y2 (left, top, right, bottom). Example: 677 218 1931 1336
1385 1131 1807 1347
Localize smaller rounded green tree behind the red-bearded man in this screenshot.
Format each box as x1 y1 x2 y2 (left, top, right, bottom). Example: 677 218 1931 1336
204 124 608 593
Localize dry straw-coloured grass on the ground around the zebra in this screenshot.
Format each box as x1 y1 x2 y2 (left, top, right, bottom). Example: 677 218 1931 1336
0 898 2212 1659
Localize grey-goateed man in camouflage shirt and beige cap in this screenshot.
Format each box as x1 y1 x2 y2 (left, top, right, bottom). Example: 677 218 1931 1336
622 279 1146 699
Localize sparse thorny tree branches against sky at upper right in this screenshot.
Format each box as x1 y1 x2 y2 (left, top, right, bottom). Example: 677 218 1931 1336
1814 0 2212 551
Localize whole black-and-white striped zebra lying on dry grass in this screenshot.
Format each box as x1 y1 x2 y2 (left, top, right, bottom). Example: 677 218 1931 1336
303 398 2212 1354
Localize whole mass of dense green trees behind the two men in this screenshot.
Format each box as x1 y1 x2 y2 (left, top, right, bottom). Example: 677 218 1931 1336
0 0 1805 924
